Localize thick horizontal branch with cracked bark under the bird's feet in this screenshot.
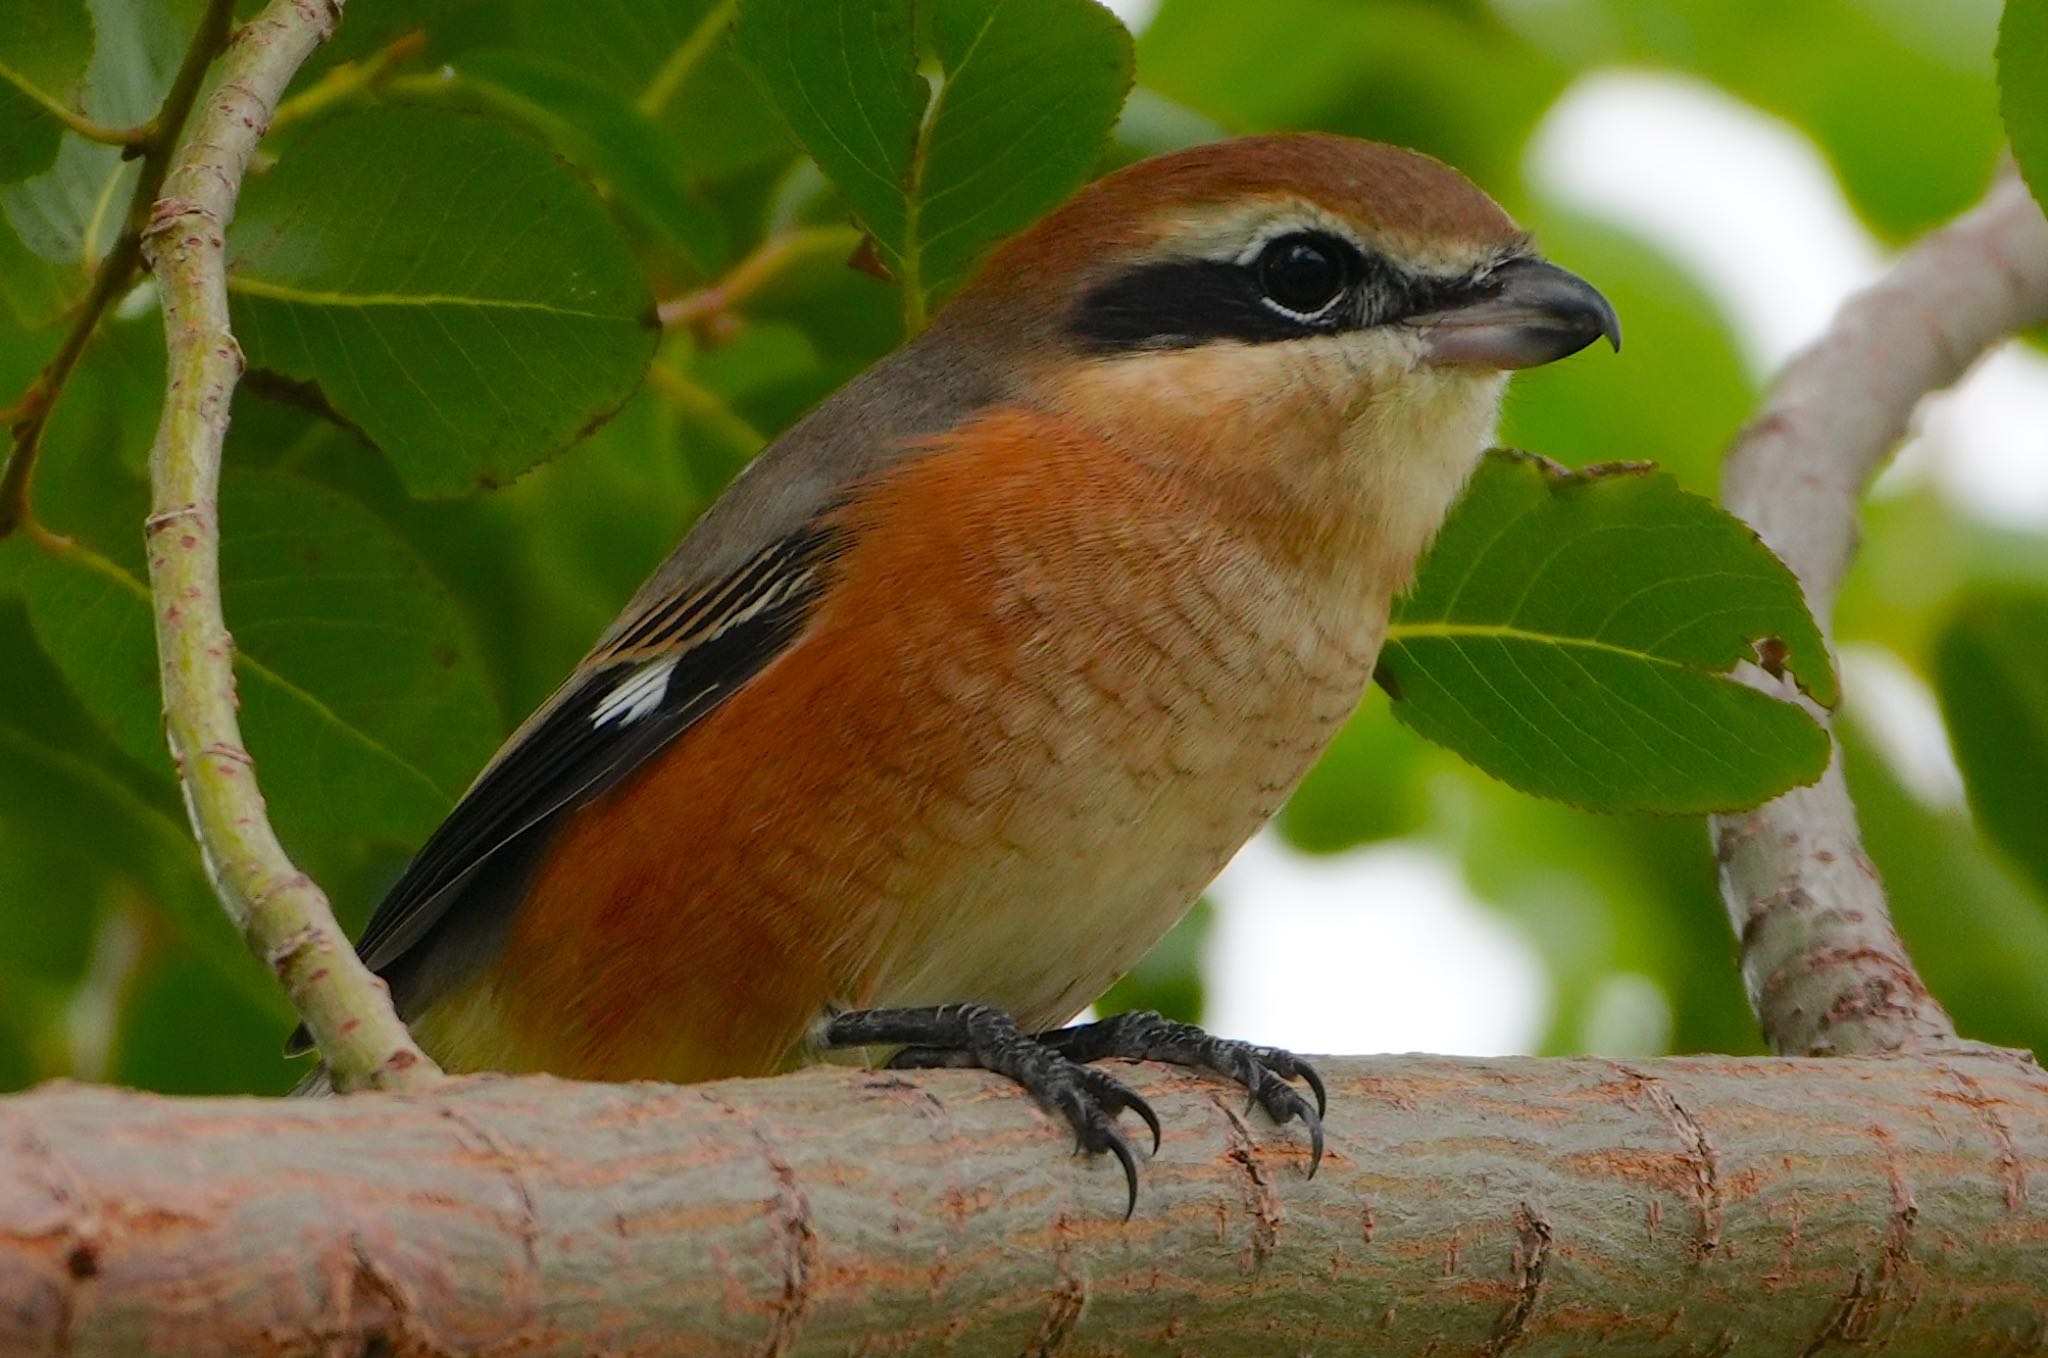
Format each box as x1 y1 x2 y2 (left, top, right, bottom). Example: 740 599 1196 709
0 1055 2048 1358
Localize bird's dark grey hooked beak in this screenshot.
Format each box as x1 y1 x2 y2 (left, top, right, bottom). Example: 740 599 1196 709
1409 256 1622 369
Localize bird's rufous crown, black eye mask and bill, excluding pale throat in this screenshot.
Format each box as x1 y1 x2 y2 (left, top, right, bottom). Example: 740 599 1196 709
956 133 1622 369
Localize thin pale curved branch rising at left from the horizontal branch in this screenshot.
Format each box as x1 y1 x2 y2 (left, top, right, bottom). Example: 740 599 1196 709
143 0 438 1088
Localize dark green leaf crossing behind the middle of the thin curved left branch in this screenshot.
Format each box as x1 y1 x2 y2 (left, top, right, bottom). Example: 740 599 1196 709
23 473 500 844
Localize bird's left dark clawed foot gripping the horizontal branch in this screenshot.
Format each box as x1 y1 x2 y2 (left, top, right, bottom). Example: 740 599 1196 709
823 1004 1159 1221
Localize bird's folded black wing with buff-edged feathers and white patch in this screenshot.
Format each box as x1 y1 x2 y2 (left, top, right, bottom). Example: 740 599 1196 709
305 524 838 1044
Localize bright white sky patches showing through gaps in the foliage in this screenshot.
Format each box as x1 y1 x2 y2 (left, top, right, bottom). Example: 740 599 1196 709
1108 0 2048 1055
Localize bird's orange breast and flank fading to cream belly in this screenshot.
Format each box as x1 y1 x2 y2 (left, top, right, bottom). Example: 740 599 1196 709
418 412 1378 1079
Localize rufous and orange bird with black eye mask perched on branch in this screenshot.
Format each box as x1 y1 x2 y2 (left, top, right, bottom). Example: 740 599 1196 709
293 133 1620 1213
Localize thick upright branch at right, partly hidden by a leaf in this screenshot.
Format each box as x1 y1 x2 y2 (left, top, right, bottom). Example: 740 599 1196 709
1714 174 2048 1055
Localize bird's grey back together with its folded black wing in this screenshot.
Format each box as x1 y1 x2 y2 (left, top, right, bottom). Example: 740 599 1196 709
289 333 995 1053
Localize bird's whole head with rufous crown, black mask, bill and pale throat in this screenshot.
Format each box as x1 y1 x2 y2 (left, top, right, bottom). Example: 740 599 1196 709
936 135 1620 578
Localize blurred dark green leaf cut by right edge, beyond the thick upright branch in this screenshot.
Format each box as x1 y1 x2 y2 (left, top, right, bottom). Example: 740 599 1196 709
1933 588 2048 895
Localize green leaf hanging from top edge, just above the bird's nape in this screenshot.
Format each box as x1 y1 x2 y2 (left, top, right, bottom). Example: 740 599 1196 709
735 0 1133 317
